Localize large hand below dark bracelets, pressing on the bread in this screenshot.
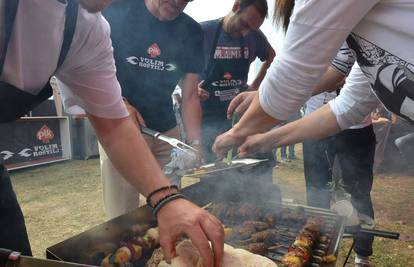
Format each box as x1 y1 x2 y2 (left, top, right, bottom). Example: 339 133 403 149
158 199 224 267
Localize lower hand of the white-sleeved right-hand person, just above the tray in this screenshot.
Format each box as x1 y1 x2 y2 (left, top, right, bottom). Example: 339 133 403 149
238 133 274 157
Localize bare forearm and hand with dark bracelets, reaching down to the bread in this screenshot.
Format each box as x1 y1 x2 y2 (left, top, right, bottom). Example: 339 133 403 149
88 114 224 266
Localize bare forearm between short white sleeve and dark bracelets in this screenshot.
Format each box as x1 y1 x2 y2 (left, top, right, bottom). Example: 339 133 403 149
88 115 170 196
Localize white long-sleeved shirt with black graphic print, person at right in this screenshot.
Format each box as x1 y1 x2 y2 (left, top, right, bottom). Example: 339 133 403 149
260 0 414 129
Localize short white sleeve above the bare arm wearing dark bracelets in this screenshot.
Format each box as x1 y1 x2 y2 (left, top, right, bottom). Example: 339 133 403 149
56 11 128 118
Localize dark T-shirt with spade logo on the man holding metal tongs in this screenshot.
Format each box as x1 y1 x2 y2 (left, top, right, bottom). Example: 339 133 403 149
103 0 204 132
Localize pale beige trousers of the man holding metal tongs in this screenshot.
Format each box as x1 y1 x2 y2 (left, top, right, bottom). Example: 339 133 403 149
99 127 179 220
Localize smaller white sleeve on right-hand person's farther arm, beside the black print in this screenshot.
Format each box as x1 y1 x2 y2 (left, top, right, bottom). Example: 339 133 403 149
329 64 380 130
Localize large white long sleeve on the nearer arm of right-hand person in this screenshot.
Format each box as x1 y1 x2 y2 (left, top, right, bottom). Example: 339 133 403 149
259 0 379 120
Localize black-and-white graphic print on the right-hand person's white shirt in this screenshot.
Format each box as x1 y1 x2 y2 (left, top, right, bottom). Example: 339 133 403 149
347 33 414 122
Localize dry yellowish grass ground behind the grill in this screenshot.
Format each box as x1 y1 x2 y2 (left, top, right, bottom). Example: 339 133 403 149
11 147 414 267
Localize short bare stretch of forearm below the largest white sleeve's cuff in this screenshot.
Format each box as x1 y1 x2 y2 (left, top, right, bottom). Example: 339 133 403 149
232 92 281 139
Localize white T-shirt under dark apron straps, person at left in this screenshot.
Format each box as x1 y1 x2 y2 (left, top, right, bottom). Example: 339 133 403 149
0 0 128 118
